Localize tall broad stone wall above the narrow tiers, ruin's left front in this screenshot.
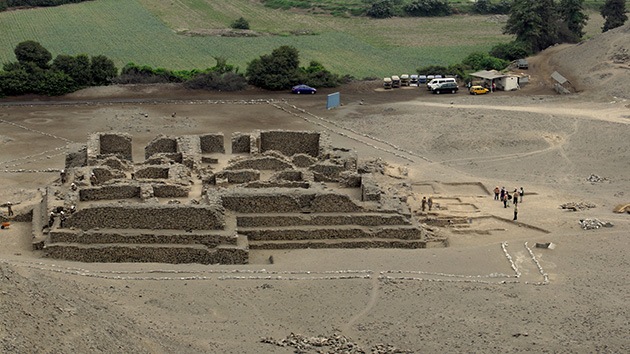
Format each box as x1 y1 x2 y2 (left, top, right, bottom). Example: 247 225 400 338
66 204 225 230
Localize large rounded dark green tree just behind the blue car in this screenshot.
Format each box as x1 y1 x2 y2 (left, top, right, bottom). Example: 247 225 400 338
246 46 300 90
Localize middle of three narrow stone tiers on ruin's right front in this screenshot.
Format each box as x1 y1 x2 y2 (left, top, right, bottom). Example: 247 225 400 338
238 225 422 243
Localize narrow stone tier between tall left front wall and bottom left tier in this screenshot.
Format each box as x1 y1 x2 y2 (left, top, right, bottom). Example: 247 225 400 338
47 229 238 247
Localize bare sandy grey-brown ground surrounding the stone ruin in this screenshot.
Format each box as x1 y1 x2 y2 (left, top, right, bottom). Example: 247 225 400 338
0 35 630 353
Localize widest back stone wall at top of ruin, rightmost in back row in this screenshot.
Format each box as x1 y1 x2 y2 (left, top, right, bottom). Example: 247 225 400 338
260 130 319 156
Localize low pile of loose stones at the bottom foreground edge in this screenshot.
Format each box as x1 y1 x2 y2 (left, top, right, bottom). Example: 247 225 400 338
260 333 411 354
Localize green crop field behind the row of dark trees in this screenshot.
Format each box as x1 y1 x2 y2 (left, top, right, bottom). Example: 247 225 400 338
0 0 608 78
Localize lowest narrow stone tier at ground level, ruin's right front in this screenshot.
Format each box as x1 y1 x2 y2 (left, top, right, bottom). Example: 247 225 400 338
249 238 426 250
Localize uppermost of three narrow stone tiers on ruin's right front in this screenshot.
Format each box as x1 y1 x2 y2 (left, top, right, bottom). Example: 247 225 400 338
236 213 411 227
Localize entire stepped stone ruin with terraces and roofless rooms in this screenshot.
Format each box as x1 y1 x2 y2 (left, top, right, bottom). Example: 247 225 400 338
33 130 434 264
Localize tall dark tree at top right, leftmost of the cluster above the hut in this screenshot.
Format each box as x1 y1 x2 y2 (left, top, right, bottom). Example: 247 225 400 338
503 0 558 53
